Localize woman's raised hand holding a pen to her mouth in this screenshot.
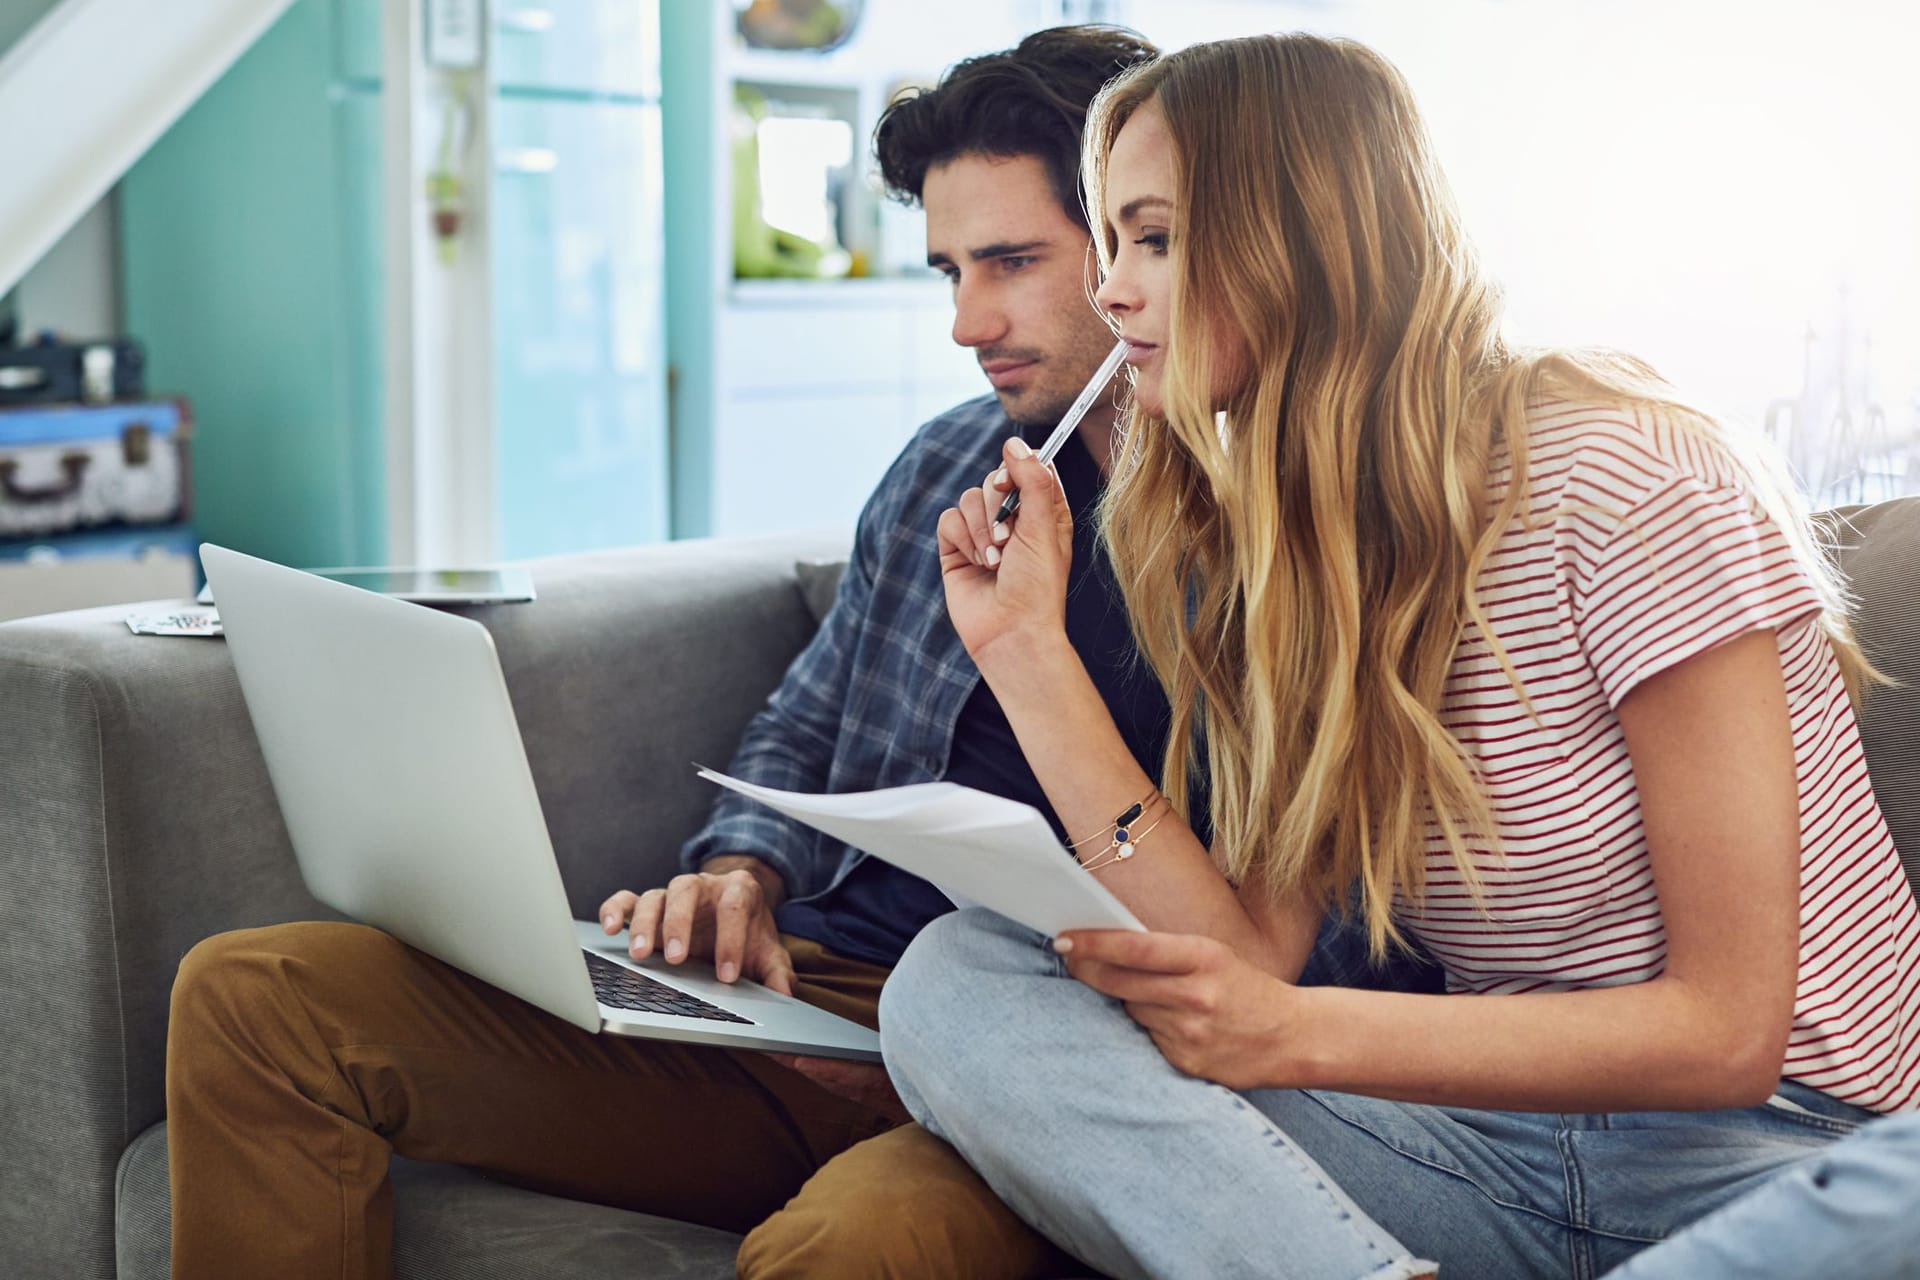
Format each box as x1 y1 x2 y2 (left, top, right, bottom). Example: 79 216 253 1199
939 436 1073 670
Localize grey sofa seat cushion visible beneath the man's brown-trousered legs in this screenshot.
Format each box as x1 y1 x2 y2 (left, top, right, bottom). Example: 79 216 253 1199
115 1125 739 1280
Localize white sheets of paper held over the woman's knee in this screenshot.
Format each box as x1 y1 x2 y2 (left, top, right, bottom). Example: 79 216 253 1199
699 768 1146 936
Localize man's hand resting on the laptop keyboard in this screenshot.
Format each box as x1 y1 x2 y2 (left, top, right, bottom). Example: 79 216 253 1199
599 856 793 996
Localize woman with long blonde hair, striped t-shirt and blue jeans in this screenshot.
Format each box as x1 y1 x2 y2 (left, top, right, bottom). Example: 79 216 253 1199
881 36 1920 1278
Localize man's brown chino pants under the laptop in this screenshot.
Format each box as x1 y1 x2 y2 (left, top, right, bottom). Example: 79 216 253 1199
167 923 1073 1280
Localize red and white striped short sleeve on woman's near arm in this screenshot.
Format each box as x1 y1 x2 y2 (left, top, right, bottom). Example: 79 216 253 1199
1571 472 1822 708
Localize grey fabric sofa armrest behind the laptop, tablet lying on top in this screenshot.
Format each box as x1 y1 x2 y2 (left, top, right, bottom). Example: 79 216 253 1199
0 533 847 1276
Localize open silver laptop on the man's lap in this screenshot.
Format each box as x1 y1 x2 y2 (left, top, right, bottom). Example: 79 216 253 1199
200 543 879 1061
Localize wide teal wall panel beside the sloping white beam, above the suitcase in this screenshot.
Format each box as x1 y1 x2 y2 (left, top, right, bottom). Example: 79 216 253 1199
121 0 386 566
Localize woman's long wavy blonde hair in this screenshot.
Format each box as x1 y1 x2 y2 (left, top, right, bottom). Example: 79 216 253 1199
1083 35 1870 956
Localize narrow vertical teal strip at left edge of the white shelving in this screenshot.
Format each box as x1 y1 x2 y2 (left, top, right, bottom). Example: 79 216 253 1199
660 0 732 537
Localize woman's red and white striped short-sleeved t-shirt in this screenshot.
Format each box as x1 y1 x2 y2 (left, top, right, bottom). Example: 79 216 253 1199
1400 403 1920 1111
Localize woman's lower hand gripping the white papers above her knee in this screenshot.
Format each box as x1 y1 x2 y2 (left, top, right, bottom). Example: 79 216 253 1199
1054 929 1298 1090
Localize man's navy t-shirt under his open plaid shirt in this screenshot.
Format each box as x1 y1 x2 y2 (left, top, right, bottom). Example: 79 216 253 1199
774 436 1169 965
